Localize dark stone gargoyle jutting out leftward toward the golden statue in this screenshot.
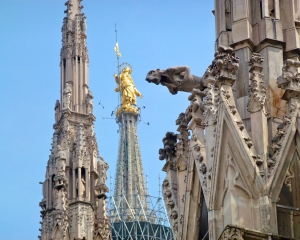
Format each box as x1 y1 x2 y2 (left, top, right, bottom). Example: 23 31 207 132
146 66 211 94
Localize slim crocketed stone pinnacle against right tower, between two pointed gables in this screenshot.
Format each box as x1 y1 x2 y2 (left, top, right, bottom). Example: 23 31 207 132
247 53 267 114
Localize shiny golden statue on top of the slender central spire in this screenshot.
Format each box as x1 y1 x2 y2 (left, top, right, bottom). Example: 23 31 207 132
114 67 143 115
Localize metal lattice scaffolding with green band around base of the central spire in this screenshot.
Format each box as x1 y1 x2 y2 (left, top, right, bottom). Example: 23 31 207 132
108 194 173 240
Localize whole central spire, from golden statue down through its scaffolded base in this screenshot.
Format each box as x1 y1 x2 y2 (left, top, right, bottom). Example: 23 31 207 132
109 62 173 240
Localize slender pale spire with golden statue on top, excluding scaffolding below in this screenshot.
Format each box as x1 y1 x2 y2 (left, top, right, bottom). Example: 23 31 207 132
114 64 146 207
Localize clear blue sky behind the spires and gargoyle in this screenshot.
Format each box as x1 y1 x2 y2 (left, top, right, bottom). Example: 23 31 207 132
0 0 215 240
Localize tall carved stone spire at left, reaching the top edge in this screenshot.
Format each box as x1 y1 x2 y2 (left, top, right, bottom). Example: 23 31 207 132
40 0 111 240
